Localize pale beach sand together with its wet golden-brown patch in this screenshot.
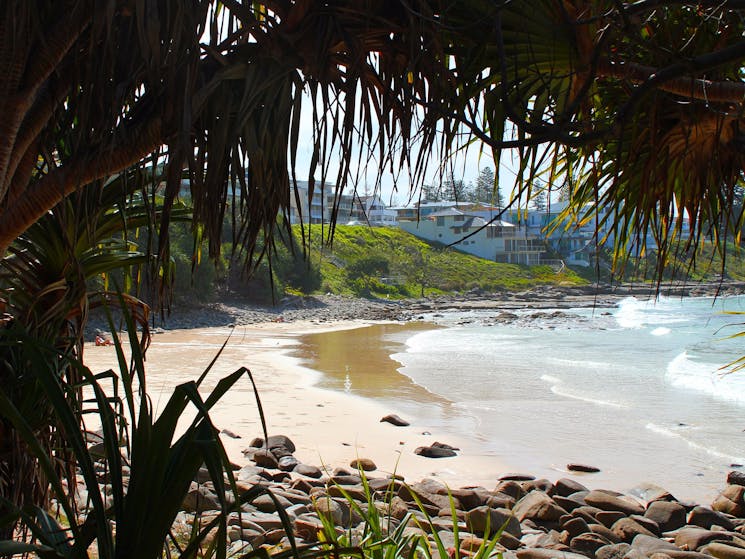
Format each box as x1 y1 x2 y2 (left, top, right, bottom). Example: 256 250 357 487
80 321 510 487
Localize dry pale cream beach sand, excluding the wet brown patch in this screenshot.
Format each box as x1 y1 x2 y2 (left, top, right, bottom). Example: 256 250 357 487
85 321 511 487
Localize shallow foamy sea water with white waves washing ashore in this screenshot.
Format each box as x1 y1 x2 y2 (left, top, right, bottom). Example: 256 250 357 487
322 297 745 501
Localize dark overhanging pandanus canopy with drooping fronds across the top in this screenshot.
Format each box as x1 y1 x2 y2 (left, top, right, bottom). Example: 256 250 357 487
0 0 745 280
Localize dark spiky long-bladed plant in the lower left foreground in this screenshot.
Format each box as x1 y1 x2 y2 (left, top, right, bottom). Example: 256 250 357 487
0 304 276 559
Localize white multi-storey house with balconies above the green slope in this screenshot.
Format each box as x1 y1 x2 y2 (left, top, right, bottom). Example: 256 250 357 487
399 208 545 266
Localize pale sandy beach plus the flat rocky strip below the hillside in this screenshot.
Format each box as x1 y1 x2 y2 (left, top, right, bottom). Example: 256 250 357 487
86 288 744 500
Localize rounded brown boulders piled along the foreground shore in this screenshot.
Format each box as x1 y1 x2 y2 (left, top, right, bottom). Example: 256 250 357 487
79 436 745 559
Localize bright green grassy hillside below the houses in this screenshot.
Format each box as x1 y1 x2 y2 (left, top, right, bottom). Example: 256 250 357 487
278 225 586 297
